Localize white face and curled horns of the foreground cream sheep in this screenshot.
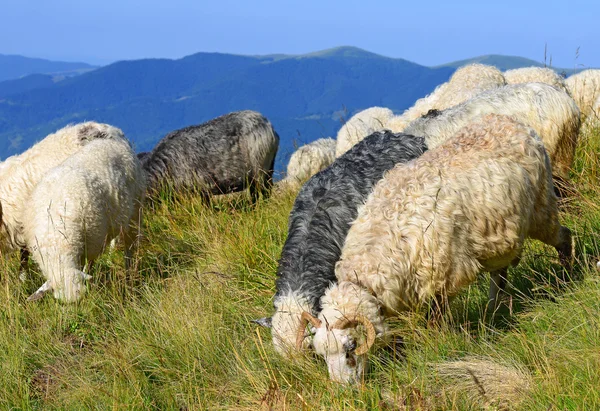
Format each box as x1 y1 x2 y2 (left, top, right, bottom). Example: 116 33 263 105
296 312 376 383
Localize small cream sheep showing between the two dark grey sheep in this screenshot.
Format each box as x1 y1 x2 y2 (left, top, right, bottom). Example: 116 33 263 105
282 138 336 186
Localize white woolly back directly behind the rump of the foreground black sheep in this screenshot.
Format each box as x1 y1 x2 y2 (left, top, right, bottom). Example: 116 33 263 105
335 107 394 157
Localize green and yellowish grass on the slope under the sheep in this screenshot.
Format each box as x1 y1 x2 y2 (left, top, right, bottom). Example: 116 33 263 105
0 127 600 410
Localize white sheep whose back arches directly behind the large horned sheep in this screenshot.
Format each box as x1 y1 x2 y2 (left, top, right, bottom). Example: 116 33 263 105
406 83 580 180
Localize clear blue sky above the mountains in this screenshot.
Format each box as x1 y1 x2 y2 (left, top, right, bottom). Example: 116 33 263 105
0 0 600 68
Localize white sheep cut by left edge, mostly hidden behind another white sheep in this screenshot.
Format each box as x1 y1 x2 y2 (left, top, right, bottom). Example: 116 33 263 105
0 121 125 281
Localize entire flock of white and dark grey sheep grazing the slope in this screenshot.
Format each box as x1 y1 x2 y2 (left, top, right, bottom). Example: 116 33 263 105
0 64 600 383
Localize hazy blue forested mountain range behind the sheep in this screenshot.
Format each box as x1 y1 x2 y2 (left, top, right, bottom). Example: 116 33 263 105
0 47 584 175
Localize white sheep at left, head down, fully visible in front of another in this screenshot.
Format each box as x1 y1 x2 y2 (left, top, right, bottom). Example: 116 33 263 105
23 139 145 302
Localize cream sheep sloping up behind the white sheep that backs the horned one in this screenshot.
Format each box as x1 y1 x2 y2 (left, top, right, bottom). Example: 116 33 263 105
387 64 506 133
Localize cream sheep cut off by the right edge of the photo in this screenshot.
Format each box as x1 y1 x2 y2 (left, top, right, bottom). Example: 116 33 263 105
565 69 600 130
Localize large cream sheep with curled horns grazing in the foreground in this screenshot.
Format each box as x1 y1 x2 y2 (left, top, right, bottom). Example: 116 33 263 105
297 114 572 383
